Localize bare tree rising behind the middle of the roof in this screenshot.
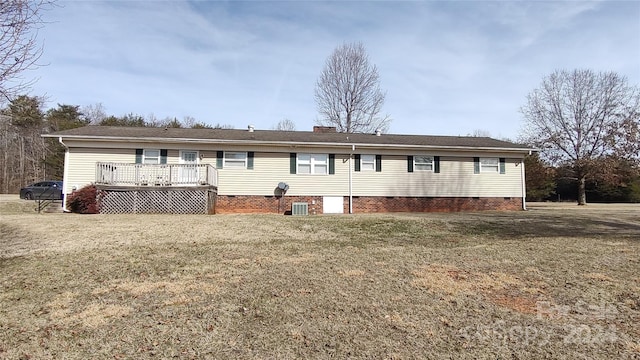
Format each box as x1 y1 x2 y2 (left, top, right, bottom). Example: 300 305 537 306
315 43 391 133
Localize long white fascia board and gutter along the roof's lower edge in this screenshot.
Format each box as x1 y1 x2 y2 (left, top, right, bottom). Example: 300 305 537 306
41 134 537 154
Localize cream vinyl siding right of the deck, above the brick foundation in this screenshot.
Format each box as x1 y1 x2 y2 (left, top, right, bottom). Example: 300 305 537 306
218 152 522 197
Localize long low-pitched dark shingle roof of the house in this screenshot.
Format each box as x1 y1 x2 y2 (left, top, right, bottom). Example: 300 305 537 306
43 126 534 152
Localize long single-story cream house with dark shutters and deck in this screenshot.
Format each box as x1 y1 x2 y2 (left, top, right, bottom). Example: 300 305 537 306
43 126 533 214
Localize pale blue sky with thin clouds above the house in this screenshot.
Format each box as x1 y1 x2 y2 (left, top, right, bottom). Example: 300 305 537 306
27 1 640 139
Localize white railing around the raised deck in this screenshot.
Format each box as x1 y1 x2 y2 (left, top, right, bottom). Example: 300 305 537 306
96 162 218 186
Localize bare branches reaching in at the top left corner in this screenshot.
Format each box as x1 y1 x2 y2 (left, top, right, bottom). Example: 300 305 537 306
0 0 53 101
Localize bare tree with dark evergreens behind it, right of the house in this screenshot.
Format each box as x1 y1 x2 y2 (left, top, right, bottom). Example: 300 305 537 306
521 69 640 205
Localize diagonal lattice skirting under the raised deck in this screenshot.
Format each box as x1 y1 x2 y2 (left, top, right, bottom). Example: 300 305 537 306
97 188 216 214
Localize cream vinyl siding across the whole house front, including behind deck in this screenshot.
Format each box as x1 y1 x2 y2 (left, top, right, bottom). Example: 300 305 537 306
65 141 522 197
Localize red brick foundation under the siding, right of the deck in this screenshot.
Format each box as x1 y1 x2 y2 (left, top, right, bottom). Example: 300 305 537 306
215 195 522 215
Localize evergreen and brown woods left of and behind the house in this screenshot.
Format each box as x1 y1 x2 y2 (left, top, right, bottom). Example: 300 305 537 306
0 95 233 194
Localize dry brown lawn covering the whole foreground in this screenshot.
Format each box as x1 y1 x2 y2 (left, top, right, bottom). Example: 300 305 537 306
0 199 640 359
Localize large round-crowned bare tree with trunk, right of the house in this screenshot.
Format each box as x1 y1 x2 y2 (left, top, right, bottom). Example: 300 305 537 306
521 70 640 205
